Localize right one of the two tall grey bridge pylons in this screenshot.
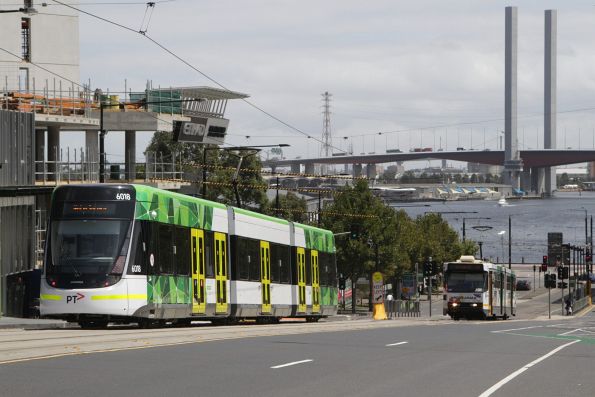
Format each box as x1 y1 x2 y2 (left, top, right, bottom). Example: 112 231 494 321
543 10 558 196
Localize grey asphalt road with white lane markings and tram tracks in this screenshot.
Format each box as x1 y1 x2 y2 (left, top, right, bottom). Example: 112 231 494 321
0 312 595 397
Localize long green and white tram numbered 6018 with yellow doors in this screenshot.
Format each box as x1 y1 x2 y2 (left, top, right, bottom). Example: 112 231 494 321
40 184 337 327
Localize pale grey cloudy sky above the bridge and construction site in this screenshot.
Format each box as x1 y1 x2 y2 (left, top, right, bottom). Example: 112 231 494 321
39 0 595 165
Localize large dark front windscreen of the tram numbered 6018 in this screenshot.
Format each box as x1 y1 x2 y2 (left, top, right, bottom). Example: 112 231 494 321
47 219 130 281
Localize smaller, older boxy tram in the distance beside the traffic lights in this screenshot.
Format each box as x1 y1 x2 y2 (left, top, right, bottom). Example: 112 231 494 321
443 256 516 320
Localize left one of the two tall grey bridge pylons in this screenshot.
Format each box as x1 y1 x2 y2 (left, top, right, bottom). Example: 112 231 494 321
504 7 523 189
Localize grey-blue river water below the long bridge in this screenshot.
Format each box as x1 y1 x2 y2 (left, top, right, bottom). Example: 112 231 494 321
392 192 595 263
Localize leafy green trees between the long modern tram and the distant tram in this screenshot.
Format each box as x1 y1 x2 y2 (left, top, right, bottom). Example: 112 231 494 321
323 181 472 279
